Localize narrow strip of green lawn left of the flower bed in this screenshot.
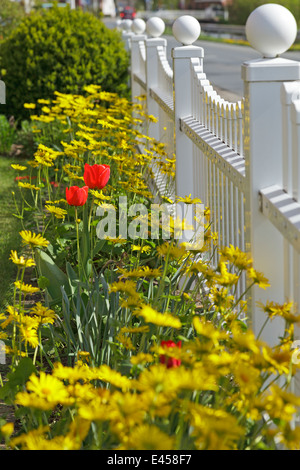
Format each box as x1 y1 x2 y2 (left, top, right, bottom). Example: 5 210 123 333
0 155 22 309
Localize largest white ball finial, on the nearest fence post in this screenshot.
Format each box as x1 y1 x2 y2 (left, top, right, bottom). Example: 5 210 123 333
246 3 297 58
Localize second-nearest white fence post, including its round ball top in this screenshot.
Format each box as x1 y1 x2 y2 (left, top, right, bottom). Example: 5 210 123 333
172 16 204 197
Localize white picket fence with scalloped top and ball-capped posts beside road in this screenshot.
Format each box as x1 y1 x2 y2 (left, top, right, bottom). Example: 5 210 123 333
123 5 300 378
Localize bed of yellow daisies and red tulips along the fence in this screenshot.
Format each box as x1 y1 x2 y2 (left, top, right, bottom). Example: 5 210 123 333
0 86 300 450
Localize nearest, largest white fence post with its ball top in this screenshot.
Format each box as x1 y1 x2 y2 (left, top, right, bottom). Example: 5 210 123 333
242 4 300 344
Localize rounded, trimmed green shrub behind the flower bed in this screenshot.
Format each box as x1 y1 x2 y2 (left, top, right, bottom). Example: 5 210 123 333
0 7 128 120
